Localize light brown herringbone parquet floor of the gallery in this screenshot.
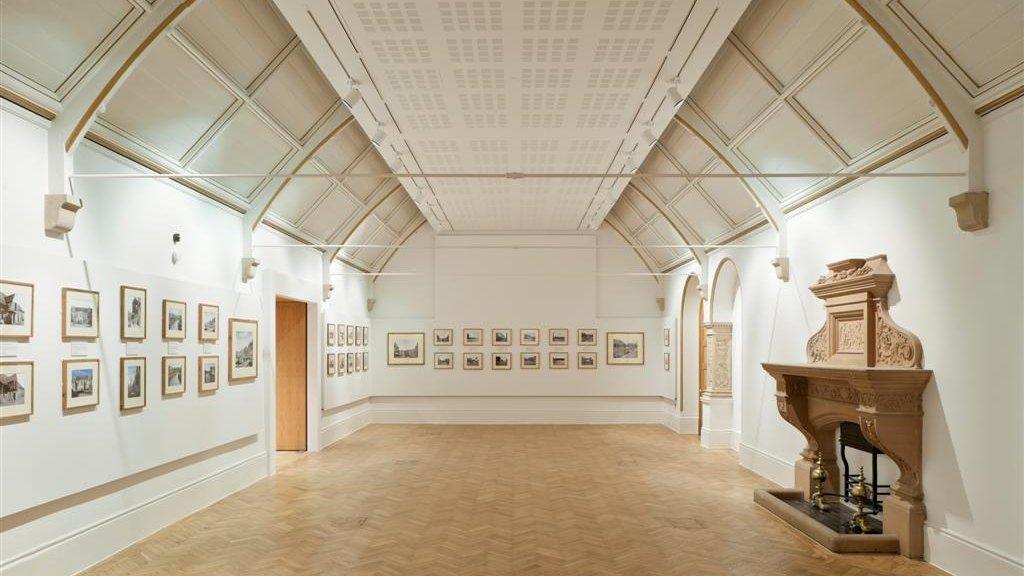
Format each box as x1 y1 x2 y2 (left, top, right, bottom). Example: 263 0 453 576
81 425 943 576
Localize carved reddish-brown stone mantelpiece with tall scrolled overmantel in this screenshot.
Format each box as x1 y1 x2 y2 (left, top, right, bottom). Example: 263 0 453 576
762 255 932 558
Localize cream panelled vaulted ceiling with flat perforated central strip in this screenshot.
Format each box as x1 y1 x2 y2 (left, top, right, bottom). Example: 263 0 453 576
0 0 1024 270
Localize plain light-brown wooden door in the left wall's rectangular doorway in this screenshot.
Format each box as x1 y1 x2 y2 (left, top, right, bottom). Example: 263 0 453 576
276 300 306 451
